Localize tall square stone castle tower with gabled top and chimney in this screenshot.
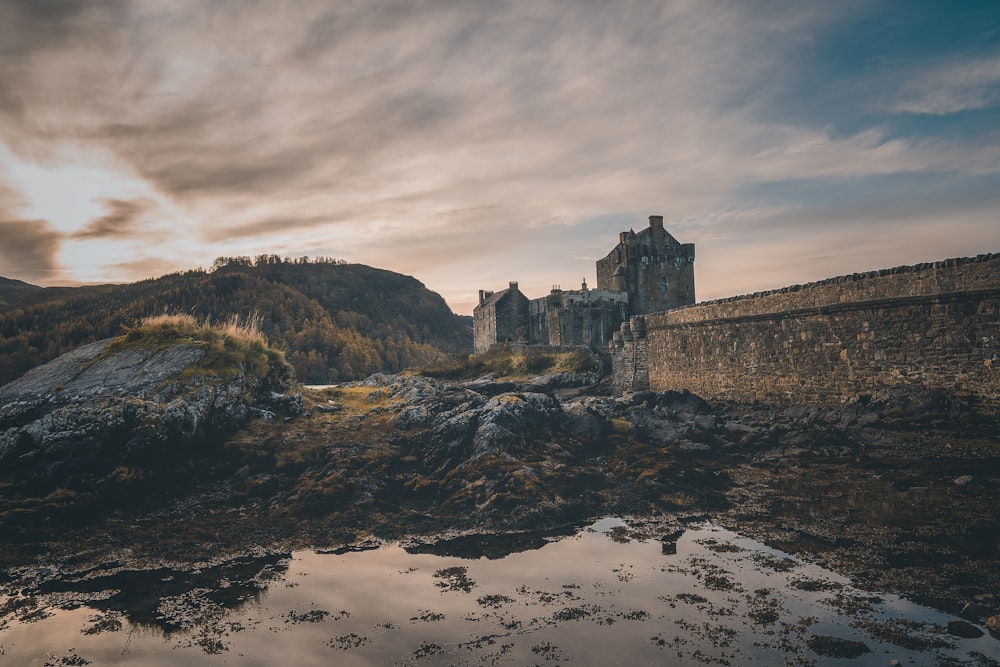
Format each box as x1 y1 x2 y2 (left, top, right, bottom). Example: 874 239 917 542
597 215 694 315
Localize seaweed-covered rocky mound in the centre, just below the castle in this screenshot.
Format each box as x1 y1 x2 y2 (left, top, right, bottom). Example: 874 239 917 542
278 374 732 529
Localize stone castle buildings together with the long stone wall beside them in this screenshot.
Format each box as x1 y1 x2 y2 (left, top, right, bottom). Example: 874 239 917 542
474 215 1000 416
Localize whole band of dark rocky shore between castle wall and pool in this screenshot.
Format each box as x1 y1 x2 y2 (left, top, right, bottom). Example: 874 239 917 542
0 358 1000 628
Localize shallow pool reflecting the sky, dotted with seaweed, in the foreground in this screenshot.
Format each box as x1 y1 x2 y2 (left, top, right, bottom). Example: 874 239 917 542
0 519 1000 666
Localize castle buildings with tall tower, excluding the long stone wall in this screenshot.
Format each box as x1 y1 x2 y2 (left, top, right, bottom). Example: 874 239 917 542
473 215 694 354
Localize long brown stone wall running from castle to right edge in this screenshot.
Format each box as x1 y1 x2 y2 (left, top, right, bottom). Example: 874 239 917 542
632 255 1000 409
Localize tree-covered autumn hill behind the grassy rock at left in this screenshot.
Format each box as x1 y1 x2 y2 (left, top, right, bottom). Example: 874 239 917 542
0 256 472 384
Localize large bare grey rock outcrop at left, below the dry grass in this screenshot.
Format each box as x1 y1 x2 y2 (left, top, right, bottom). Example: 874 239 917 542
0 339 301 494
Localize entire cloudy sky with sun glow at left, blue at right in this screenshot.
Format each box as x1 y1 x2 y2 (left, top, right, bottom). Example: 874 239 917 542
0 0 1000 314
